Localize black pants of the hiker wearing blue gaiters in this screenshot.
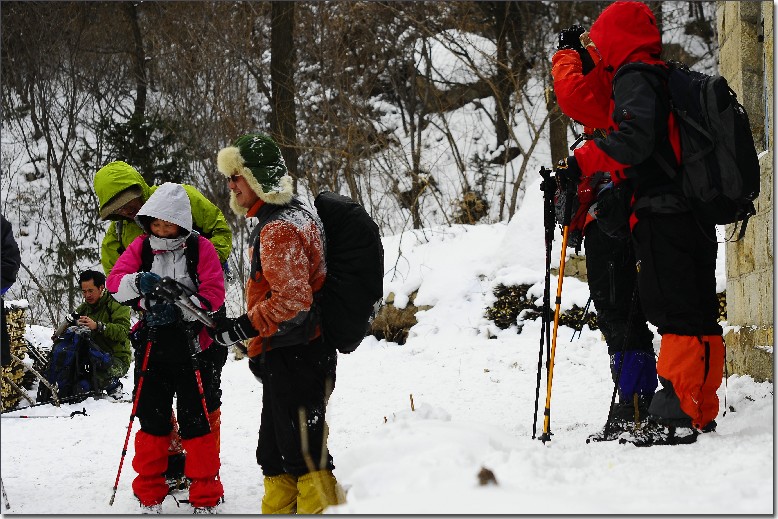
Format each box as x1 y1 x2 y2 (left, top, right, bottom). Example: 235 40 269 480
584 222 654 355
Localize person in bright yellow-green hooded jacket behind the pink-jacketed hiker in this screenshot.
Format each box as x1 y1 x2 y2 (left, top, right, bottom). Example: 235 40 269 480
94 160 232 275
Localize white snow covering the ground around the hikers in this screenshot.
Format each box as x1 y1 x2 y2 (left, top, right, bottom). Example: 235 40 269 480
0 180 774 514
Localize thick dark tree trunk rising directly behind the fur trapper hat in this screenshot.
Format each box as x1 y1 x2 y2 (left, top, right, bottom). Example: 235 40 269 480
270 2 298 186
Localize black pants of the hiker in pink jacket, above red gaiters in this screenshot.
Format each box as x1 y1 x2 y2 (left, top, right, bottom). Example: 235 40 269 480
135 325 226 439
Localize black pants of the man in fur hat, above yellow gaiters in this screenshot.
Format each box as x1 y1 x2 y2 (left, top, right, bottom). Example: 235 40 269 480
257 339 338 477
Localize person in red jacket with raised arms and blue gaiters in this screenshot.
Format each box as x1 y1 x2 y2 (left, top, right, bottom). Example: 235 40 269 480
551 25 657 439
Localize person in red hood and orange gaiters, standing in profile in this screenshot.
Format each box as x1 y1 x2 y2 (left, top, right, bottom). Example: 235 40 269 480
556 2 724 445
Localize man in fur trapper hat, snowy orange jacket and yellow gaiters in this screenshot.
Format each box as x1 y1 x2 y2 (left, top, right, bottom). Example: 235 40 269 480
209 134 339 514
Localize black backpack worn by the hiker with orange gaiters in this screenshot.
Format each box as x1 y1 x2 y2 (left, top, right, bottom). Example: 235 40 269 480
614 61 760 237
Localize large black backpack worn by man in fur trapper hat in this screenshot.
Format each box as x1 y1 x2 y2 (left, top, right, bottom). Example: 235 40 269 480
313 191 384 353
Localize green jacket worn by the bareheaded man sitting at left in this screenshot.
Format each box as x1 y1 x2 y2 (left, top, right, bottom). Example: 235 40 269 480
76 290 132 366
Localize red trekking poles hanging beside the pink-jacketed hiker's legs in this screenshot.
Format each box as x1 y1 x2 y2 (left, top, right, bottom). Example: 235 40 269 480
108 277 216 506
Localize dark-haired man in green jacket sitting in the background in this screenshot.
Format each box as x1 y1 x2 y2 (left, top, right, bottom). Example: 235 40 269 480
54 270 132 400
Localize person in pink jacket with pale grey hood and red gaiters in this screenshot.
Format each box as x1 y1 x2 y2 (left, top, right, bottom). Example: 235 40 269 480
106 183 224 513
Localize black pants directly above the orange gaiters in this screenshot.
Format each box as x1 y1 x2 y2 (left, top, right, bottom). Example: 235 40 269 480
632 213 722 335
